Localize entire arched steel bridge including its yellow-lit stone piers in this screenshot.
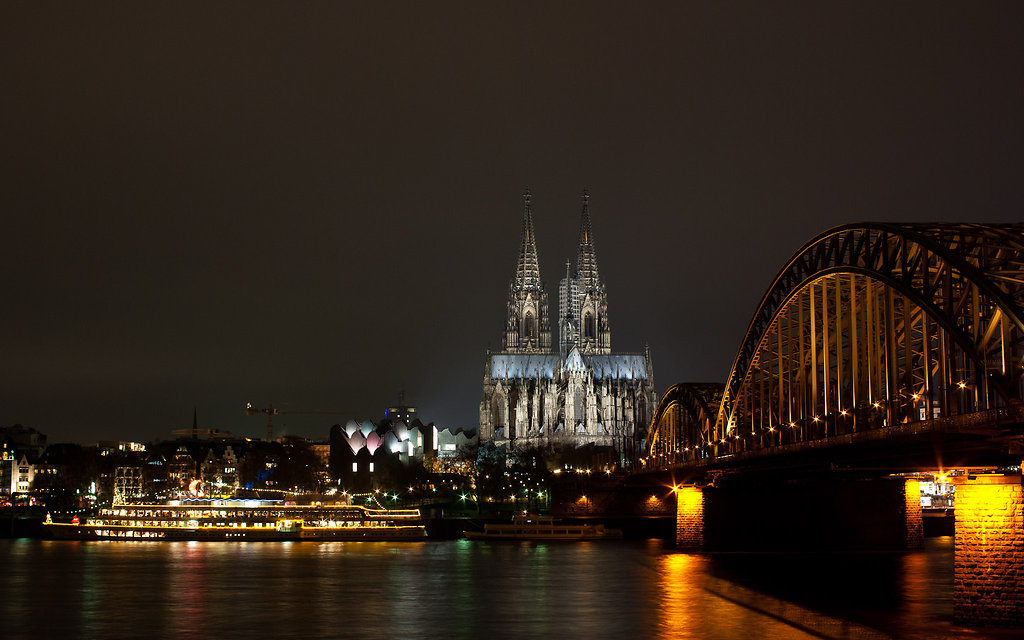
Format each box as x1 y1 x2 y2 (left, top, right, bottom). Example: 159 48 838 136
643 223 1024 626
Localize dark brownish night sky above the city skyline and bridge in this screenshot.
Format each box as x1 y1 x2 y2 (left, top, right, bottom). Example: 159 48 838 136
0 1 1024 441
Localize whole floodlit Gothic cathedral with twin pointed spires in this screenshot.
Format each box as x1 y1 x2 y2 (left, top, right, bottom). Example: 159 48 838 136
479 191 657 461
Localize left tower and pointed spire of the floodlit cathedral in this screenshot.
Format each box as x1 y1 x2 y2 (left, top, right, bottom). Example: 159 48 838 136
502 190 551 353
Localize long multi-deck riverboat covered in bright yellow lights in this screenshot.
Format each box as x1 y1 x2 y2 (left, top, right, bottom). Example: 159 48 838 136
43 500 426 541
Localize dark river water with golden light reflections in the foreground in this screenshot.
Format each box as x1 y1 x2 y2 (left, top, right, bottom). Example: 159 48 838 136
0 538 1015 640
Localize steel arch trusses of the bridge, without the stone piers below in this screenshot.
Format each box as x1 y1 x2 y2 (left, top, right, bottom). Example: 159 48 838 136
644 223 1024 468
